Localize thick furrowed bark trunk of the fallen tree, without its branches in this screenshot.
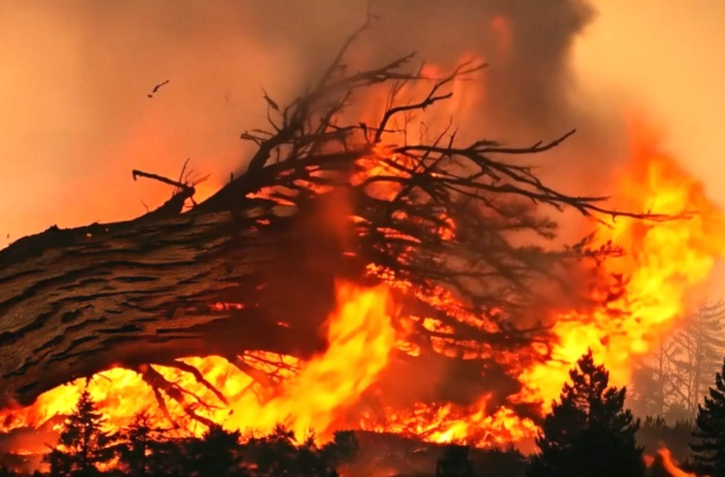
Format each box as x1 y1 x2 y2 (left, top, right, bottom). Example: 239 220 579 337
0 197 350 406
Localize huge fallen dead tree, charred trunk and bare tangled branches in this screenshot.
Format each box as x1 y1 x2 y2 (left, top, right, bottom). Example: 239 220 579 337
0 19 662 412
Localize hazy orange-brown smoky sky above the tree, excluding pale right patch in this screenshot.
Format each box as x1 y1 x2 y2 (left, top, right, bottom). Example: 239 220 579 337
0 0 617 245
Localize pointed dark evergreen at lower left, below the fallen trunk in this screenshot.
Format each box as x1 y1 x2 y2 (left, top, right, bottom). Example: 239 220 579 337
46 389 111 477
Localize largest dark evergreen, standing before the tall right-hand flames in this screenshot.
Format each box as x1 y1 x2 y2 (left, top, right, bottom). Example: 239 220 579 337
529 350 645 477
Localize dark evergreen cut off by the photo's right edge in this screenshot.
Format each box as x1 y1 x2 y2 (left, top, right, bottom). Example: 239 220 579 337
690 361 725 477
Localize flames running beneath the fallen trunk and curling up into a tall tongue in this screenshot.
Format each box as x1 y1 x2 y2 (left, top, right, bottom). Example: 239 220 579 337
0 282 396 444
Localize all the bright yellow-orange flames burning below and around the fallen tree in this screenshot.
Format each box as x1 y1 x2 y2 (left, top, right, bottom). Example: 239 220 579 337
0 53 725 462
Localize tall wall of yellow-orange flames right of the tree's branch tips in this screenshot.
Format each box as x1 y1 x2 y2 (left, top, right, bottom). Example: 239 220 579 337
520 121 725 405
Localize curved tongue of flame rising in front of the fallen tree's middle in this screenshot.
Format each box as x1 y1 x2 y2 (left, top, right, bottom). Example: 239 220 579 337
226 284 396 435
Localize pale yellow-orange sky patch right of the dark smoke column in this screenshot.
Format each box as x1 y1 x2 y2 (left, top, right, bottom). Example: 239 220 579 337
574 0 725 204
